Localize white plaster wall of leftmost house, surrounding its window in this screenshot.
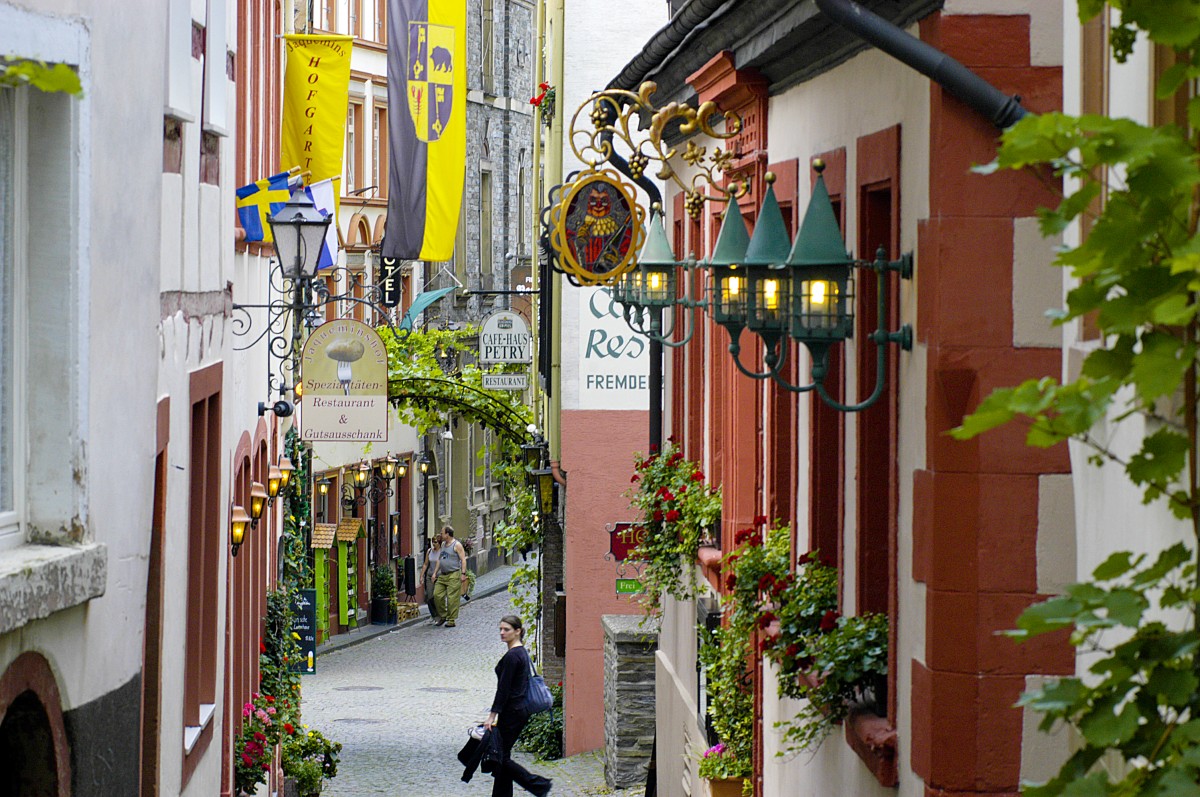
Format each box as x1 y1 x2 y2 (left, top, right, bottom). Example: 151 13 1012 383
0 0 179 795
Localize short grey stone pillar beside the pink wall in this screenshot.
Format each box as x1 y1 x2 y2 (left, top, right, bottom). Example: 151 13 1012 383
601 615 659 789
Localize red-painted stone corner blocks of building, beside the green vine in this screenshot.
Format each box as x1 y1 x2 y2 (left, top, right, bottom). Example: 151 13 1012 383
901 14 1074 797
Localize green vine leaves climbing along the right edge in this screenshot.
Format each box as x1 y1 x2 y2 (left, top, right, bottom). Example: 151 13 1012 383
953 0 1200 797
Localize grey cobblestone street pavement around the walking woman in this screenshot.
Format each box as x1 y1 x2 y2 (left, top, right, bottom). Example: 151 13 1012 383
304 574 642 797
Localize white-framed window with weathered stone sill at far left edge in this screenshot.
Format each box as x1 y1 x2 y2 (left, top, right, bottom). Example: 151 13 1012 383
0 2 108 633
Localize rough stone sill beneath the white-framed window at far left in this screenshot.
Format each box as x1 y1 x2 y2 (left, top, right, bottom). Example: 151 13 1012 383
0 543 108 634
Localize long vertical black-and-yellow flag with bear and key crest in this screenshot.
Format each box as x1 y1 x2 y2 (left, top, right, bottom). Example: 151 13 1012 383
383 0 467 260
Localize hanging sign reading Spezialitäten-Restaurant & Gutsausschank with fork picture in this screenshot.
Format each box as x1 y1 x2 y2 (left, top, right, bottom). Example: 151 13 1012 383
300 318 388 443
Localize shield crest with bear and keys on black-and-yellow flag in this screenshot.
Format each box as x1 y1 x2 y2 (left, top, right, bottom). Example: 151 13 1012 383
406 22 455 143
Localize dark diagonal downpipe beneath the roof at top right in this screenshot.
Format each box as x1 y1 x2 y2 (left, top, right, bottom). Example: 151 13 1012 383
814 0 1027 130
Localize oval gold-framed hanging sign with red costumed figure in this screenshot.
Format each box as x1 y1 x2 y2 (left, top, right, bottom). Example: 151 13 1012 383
550 169 646 286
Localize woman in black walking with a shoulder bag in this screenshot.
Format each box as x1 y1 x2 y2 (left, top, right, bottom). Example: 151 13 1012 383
484 615 550 797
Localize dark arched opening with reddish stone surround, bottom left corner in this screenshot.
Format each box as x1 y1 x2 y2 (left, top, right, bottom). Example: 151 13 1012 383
0 652 71 797
